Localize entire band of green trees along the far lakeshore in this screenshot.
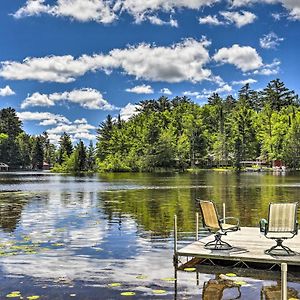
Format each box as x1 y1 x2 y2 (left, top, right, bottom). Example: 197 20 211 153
0 79 300 172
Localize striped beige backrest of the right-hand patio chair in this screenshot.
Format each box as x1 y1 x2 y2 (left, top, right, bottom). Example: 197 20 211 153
268 202 298 232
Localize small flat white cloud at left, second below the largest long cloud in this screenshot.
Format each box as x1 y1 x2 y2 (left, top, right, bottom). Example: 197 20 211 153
17 111 70 126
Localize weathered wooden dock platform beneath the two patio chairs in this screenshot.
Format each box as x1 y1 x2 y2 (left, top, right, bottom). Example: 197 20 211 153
174 227 300 266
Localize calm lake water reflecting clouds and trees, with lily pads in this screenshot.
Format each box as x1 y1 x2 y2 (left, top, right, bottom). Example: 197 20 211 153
0 171 300 300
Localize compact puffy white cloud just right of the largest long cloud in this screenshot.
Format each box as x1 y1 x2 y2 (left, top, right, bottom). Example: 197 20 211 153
214 44 263 72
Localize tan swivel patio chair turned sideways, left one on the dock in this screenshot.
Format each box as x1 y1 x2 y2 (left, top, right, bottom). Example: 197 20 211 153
199 200 240 250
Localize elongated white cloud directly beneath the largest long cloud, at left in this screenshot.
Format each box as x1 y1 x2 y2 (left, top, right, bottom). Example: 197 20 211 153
21 88 116 110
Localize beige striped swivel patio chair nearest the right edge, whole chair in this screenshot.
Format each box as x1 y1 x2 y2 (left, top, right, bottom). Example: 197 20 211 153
260 202 298 256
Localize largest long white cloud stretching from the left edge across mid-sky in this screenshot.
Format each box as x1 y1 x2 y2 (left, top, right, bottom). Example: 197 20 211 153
0 38 211 83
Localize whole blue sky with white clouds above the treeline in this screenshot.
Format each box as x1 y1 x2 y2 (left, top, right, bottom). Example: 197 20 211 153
0 0 300 142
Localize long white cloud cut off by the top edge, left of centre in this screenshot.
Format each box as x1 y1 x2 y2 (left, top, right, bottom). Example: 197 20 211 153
13 0 220 27
